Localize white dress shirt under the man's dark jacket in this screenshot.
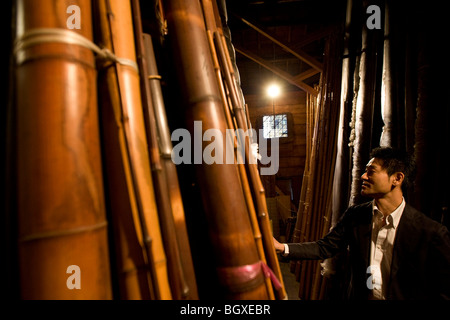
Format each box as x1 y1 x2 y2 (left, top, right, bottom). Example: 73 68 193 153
367 198 406 300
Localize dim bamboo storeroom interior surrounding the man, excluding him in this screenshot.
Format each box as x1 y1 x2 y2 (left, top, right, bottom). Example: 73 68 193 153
0 0 450 300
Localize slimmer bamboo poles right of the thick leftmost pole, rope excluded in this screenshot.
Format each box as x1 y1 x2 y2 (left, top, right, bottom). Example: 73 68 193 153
94 0 198 299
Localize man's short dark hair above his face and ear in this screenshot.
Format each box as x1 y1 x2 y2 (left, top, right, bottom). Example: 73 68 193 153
370 147 416 191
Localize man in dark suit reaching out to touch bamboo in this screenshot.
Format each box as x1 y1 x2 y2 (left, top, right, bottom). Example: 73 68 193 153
274 147 450 300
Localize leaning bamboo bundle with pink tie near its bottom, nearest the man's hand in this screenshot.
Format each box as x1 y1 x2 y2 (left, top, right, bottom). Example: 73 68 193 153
164 0 285 299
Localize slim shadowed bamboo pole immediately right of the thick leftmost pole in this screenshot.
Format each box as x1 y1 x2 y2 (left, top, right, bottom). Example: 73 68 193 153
94 1 155 299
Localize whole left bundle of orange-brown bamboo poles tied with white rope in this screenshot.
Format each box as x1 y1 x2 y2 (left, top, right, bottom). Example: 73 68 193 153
11 0 198 300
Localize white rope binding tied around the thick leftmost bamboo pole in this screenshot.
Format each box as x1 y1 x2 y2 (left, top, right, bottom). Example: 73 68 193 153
14 28 139 72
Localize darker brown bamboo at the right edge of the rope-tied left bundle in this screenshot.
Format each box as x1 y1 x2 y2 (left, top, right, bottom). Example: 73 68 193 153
131 0 198 300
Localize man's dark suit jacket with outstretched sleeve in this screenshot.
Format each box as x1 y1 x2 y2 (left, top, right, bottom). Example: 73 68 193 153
288 202 450 300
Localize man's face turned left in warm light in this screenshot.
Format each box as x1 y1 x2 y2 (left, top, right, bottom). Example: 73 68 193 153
361 158 394 199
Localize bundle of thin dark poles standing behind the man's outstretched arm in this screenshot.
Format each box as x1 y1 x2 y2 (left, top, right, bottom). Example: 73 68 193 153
291 32 341 300
